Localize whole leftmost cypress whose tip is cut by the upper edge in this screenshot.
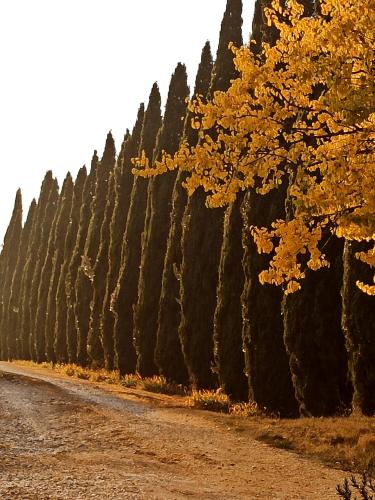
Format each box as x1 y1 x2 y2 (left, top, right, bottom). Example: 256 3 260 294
179 0 242 388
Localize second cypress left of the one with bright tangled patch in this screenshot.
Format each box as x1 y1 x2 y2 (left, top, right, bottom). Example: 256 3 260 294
53 167 87 363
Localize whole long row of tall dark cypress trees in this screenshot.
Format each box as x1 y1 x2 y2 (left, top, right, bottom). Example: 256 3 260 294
0 0 375 416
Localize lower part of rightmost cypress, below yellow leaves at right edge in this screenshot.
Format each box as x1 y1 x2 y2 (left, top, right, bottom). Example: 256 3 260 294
342 241 375 415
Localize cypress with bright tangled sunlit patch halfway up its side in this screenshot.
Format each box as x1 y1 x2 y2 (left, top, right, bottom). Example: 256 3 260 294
84 132 116 366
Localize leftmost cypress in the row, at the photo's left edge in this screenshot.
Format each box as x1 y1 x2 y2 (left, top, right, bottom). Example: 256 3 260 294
0 189 22 359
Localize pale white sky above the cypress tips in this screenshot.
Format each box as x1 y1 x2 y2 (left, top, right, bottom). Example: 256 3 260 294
0 0 255 241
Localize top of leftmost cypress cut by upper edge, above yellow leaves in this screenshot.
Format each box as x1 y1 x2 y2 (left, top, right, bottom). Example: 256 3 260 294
210 0 243 94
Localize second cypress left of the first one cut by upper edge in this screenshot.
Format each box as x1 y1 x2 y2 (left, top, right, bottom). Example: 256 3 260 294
134 63 189 376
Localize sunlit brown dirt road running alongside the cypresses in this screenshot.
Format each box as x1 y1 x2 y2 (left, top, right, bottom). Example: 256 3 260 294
0 363 345 500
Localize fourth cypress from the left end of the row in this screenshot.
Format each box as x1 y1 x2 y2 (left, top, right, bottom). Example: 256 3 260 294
35 173 72 362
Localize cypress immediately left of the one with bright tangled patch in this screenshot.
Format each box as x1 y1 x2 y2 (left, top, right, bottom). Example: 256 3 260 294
69 151 99 366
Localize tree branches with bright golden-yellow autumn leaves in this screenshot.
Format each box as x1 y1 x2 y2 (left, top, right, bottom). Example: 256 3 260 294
135 0 375 295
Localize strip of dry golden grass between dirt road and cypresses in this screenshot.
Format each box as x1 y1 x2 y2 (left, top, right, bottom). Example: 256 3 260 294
8 361 375 476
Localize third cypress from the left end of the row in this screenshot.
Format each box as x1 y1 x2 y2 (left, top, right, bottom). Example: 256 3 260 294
18 171 58 359
